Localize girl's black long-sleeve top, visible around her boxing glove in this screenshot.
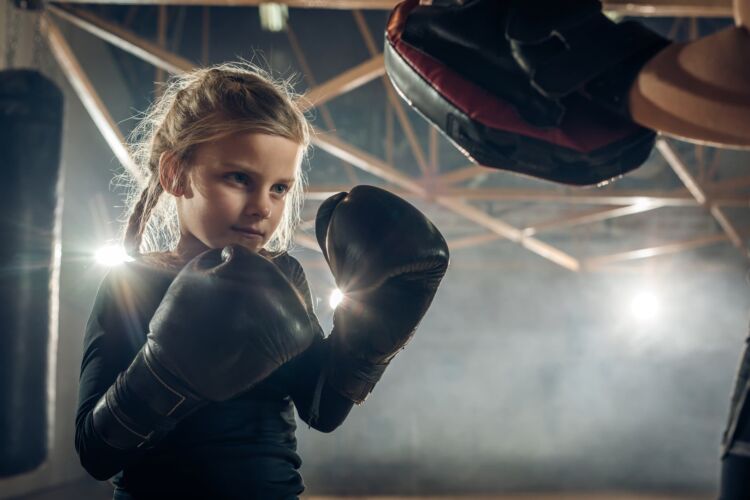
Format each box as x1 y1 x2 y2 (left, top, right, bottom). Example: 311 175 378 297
75 254 352 499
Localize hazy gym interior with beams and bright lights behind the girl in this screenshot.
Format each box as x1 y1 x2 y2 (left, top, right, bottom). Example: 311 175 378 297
0 0 750 499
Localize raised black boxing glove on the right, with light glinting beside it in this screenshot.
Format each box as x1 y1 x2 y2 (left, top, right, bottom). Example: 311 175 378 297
315 186 449 404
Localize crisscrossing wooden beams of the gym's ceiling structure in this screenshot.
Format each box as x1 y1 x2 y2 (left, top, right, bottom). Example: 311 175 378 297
40 0 750 271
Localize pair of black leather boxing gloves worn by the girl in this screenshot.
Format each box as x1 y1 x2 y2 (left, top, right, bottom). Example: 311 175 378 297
93 186 448 450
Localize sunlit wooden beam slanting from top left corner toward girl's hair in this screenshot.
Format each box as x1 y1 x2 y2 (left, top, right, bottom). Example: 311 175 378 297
40 13 144 184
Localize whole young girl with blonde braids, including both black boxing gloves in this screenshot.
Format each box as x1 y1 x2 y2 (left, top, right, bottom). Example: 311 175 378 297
76 60 447 499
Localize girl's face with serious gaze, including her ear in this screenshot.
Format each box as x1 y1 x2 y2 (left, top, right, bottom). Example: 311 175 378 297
175 132 302 254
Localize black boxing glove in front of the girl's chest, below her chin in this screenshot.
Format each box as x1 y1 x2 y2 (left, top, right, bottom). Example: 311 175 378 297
93 246 316 449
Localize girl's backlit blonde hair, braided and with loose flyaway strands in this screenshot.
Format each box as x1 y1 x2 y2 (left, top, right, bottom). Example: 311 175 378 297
123 62 311 254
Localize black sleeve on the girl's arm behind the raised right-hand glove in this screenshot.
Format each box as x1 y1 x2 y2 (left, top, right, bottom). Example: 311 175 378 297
286 256 354 432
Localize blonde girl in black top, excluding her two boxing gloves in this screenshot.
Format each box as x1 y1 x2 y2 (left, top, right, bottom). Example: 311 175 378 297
76 65 353 499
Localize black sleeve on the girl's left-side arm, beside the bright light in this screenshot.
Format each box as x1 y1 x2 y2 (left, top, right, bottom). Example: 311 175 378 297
75 271 151 480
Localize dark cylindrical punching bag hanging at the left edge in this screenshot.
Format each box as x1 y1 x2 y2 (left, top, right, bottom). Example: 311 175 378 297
0 70 63 477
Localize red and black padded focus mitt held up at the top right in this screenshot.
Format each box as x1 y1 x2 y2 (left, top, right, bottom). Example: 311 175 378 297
385 0 665 185
